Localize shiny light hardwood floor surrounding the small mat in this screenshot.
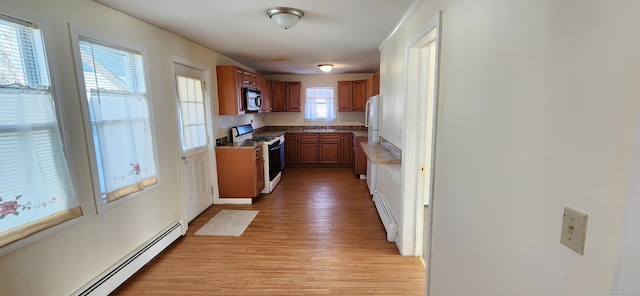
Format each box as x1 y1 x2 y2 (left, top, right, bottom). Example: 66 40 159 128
113 168 425 295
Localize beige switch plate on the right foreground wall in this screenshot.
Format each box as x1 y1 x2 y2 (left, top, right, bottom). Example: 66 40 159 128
560 207 589 255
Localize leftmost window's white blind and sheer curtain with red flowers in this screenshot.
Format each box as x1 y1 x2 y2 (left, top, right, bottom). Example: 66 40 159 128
0 15 82 247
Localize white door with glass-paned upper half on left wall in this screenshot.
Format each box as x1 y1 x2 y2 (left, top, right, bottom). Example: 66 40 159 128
173 62 213 223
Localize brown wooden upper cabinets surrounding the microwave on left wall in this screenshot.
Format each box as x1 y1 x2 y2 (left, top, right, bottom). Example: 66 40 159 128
216 66 271 115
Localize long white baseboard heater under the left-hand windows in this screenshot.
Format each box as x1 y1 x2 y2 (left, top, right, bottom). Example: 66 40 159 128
71 221 182 296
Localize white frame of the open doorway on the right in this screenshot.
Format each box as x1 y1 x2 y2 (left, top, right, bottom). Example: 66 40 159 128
403 11 442 295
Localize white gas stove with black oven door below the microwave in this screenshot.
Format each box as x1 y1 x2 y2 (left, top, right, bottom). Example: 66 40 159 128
231 124 284 193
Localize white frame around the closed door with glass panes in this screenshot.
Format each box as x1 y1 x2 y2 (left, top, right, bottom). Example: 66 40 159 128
170 55 218 227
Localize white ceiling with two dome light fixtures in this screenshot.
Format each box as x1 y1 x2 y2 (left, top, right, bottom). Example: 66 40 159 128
94 0 413 75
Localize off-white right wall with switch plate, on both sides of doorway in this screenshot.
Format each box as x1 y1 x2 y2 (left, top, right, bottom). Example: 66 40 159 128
381 0 640 295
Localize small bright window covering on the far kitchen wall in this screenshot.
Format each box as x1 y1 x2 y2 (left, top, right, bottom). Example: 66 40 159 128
304 87 336 121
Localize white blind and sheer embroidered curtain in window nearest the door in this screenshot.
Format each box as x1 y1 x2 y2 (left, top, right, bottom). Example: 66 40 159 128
79 37 157 207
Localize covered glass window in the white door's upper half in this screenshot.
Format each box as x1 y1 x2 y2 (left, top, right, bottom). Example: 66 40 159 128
176 75 207 152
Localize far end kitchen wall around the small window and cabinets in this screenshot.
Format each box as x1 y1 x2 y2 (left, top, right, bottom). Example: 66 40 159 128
266 73 372 126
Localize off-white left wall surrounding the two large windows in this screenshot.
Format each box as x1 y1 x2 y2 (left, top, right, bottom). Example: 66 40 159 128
0 0 250 295
